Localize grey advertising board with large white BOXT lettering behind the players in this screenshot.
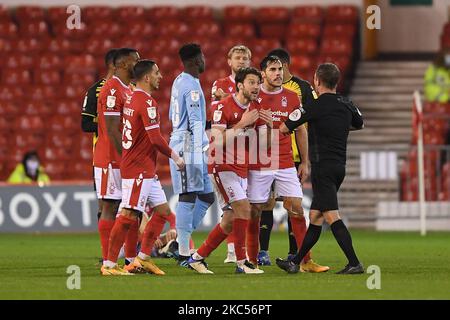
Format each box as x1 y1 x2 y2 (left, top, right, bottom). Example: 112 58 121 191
0 183 311 233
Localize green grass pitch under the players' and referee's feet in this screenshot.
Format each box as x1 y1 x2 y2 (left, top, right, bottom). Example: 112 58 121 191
0 231 450 300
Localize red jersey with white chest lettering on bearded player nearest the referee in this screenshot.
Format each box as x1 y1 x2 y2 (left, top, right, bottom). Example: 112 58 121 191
249 85 301 170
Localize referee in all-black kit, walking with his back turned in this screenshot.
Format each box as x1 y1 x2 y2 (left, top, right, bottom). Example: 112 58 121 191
276 63 364 274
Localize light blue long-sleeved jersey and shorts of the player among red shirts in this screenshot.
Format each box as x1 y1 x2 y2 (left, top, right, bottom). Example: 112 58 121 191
169 72 212 194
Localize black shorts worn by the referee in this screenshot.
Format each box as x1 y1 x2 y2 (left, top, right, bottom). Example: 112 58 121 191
311 162 345 212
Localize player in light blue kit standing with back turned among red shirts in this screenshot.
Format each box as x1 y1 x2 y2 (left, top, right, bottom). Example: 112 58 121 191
169 43 214 266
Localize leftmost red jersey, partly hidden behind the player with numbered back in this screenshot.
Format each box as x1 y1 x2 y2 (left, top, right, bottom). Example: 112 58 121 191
94 76 133 169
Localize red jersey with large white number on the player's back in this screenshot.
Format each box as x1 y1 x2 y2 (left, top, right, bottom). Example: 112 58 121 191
120 89 160 179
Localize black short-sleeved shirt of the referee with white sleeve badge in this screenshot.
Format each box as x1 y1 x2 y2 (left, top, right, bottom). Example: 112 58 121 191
285 93 364 165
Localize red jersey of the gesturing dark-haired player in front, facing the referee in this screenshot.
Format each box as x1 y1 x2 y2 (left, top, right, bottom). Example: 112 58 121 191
211 94 265 178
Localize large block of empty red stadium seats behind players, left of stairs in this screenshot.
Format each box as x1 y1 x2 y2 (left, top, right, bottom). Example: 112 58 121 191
0 6 359 182
